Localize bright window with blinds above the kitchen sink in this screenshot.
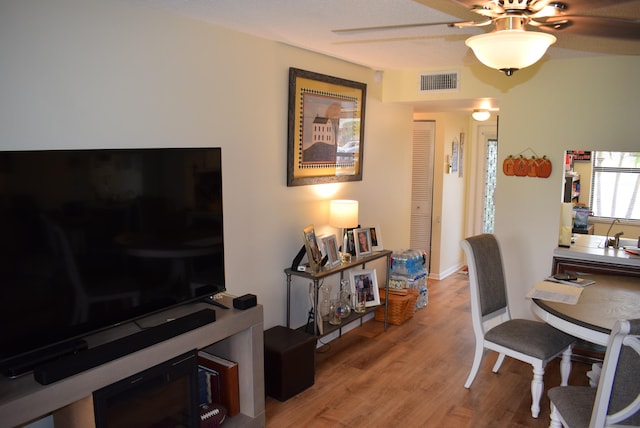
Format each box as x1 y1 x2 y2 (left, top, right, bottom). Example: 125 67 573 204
591 152 640 220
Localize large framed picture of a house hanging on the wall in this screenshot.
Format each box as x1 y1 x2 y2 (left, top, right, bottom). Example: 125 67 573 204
287 68 367 186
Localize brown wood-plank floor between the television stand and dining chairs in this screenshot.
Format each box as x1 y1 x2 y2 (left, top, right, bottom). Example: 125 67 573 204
266 273 590 428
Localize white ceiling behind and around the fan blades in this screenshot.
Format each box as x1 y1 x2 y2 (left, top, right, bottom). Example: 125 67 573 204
126 0 640 111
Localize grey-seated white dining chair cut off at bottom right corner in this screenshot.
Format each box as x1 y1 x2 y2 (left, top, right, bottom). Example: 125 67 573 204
547 319 640 428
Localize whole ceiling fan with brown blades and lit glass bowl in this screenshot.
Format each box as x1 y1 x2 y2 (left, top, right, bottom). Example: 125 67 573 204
333 0 640 76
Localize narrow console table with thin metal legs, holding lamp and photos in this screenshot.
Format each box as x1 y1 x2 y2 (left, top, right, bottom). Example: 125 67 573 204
284 250 392 336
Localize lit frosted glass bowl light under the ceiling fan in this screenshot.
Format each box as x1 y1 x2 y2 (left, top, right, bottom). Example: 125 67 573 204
465 29 556 76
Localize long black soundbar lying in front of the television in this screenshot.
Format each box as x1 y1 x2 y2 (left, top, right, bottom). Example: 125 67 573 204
33 309 216 385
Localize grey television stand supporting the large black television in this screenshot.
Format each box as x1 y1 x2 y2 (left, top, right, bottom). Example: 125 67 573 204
0 302 265 428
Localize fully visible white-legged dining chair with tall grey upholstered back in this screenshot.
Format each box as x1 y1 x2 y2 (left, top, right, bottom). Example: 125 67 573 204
460 234 576 418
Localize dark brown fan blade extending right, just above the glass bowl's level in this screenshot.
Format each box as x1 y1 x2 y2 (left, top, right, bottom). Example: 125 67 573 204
530 16 640 40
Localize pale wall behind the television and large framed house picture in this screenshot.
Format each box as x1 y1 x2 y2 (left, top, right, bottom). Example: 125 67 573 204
0 0 412 328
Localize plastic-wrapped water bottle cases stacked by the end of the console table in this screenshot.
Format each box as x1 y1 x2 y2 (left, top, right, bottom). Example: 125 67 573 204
389 250 429 309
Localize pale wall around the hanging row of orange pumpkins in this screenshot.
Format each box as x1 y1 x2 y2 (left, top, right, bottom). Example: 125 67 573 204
496 56 640 316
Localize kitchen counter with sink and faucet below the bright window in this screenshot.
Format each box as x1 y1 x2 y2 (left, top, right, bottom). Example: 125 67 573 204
552 234 640 276
